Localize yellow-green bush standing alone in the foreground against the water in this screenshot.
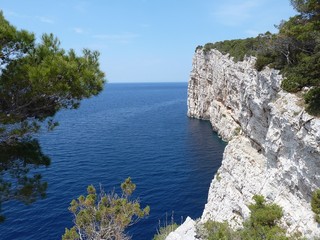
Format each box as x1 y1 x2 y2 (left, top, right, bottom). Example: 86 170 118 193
62 178 150 240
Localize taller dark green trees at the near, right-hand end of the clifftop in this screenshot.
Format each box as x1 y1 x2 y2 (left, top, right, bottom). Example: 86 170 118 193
256 0 320 115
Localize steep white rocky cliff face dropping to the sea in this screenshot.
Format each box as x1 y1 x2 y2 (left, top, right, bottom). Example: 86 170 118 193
166 50 320 239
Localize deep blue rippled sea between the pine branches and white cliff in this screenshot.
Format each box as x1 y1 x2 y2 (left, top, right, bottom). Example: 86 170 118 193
0 83 225 240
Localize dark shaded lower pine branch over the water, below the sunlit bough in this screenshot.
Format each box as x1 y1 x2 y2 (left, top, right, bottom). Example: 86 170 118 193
0 139 50 222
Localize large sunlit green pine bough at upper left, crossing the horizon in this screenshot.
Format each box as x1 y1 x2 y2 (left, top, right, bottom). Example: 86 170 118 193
0 12 104 142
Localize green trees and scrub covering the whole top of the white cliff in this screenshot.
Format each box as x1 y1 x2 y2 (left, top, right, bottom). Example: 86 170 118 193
197 0 320 115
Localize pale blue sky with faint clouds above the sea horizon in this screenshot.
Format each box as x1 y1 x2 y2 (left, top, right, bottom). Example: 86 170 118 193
0 0 295 83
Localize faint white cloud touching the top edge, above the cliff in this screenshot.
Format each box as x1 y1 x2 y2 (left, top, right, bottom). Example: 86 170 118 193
213 0 264 26
